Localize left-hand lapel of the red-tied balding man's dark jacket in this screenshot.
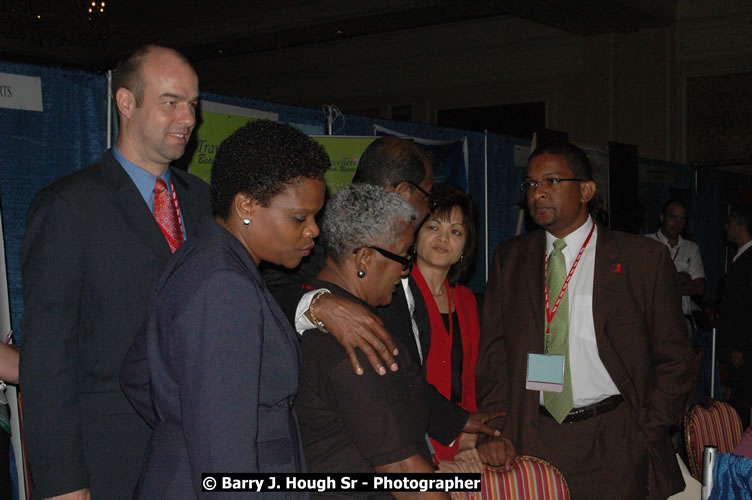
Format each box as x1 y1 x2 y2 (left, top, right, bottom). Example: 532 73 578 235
101 152 170 260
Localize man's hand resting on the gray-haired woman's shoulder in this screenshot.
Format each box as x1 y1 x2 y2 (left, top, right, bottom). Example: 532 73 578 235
316 293 399 375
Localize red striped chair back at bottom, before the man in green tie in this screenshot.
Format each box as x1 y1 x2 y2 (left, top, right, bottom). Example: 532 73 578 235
452 455 569 500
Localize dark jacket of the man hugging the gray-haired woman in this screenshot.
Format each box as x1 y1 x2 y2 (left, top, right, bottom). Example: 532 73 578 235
263 250 469 444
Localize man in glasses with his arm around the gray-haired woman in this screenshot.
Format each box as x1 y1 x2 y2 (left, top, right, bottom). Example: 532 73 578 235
264 136 511 461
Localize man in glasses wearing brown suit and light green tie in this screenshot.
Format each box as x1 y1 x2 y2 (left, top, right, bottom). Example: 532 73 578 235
476 144 691 499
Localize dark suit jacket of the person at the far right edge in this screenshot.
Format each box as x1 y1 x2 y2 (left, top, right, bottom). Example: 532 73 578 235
718 248 752 356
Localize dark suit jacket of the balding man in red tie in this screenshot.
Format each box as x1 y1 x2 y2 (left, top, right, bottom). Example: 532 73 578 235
20 152 210 498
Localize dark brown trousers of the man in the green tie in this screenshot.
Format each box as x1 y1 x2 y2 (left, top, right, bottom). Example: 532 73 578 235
538 402 648 500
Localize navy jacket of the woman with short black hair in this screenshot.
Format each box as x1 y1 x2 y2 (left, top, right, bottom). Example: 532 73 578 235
121 217 304 500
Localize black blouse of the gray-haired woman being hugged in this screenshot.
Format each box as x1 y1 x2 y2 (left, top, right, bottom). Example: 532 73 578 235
295 282 431 486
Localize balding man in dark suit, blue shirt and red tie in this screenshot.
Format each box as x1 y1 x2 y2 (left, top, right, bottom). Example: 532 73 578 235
20 45 210 499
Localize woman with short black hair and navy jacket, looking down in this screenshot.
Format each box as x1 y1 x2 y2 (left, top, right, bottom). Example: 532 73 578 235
121 121 329 499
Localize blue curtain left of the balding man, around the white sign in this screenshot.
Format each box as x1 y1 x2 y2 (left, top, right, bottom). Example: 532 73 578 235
0 61 107 337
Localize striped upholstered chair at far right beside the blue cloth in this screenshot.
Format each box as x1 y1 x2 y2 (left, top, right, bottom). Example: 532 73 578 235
684 400 743 481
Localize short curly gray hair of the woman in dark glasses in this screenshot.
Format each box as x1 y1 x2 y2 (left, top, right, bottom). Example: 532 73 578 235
322 184 418 263
